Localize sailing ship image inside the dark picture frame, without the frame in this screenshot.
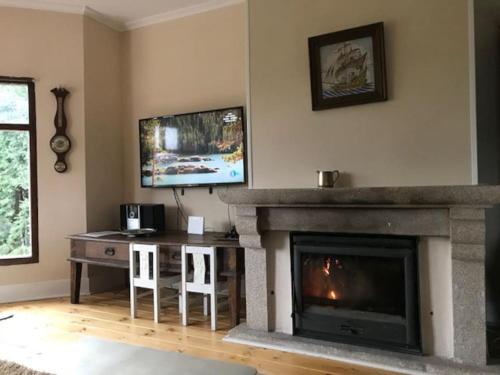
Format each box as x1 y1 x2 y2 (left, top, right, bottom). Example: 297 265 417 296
320 37 375 98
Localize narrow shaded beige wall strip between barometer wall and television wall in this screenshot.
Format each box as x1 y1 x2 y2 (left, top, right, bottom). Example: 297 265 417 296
83 17 123 231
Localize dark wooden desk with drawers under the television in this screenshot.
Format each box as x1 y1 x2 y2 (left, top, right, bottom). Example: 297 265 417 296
67 231 243 326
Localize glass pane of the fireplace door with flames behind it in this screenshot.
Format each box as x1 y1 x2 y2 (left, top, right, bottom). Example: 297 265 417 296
300 254 406 318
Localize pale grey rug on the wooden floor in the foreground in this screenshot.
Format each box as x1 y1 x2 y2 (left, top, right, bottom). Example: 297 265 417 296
0 338 257 375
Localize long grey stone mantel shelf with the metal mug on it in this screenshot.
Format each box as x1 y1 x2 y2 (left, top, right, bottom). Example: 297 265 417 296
218 185 500 207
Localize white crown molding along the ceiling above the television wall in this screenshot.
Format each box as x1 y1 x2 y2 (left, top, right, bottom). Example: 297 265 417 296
125 0 246 30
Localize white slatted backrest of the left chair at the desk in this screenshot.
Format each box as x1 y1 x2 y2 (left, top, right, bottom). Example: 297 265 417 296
130 243 160 288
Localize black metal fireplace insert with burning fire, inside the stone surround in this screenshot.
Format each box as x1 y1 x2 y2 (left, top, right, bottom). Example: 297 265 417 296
290 232 422 354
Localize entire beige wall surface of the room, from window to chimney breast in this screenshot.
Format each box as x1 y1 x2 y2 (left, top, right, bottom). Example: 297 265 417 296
0 0 471 302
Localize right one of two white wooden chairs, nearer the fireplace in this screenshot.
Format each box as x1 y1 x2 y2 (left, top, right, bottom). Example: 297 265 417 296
181 245 224 331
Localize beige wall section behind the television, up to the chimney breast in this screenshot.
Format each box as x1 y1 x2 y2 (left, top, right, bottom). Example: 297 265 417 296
122 4 245 230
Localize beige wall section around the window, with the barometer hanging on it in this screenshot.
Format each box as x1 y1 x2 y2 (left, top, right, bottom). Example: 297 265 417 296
0 7 86 285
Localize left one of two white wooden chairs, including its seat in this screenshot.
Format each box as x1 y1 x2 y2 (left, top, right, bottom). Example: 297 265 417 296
129 243 181 323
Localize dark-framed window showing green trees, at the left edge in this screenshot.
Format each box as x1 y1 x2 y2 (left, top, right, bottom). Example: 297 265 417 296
0 77 38 265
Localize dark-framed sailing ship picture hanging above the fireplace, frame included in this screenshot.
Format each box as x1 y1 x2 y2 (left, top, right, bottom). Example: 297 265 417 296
309 22 387 111
